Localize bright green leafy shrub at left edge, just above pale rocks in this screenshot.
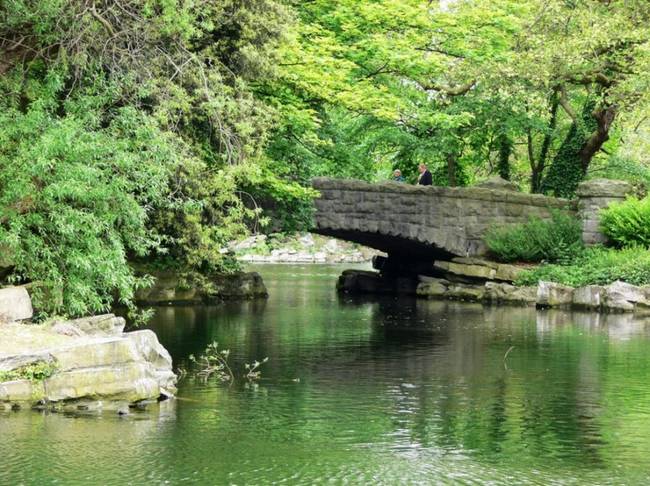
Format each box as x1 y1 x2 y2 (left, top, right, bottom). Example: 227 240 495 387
0 106 174 315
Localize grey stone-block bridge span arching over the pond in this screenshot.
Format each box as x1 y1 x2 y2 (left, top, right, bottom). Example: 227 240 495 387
313 178 578 259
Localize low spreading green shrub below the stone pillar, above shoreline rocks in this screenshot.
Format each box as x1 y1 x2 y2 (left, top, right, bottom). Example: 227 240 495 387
516 246 650 287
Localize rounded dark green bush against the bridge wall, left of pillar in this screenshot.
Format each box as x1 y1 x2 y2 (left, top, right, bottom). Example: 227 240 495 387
485 211 584 262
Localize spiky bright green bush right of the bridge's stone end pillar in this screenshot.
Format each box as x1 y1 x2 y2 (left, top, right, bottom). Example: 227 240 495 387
600 197 650 248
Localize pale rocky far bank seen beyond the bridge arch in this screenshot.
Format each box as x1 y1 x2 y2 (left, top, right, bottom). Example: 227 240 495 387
228 233 382 263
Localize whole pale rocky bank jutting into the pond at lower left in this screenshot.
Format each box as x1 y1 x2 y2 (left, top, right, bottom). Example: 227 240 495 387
0 287 176 414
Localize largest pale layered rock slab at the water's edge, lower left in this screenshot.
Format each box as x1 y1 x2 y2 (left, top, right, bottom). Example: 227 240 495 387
0 326 176 409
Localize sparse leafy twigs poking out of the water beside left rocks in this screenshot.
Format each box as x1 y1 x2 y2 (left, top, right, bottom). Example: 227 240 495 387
180 341 269 384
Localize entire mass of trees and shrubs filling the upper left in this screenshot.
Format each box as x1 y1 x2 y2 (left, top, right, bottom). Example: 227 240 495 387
0 0 289 315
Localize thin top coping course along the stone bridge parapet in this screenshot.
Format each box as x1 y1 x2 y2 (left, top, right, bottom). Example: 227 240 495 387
312 177 577 210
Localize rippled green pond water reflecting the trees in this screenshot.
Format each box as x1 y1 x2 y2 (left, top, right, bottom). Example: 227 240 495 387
0 265 650 485
